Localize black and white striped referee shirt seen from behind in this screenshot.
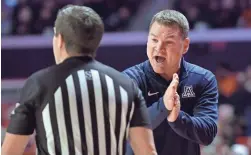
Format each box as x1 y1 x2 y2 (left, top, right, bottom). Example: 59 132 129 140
7 57 150 155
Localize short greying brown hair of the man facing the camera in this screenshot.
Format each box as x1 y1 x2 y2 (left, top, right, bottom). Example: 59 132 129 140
150 10 189 38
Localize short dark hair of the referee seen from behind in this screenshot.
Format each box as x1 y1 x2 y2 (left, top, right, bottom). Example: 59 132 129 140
55 5 104 56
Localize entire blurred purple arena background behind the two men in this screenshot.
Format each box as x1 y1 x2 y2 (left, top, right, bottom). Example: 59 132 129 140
1 0 251 155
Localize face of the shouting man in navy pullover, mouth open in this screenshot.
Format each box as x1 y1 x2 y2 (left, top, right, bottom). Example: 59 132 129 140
147 22 189 76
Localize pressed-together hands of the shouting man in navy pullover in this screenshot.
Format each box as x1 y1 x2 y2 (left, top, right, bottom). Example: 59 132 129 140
163 73 180 122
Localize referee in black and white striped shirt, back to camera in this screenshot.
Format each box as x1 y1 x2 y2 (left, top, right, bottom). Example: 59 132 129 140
2 5 156 155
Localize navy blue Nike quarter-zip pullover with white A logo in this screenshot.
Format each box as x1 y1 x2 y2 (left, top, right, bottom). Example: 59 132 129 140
124 59 218 155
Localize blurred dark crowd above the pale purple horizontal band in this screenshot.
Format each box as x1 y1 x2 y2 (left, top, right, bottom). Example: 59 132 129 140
1 0 251 35
